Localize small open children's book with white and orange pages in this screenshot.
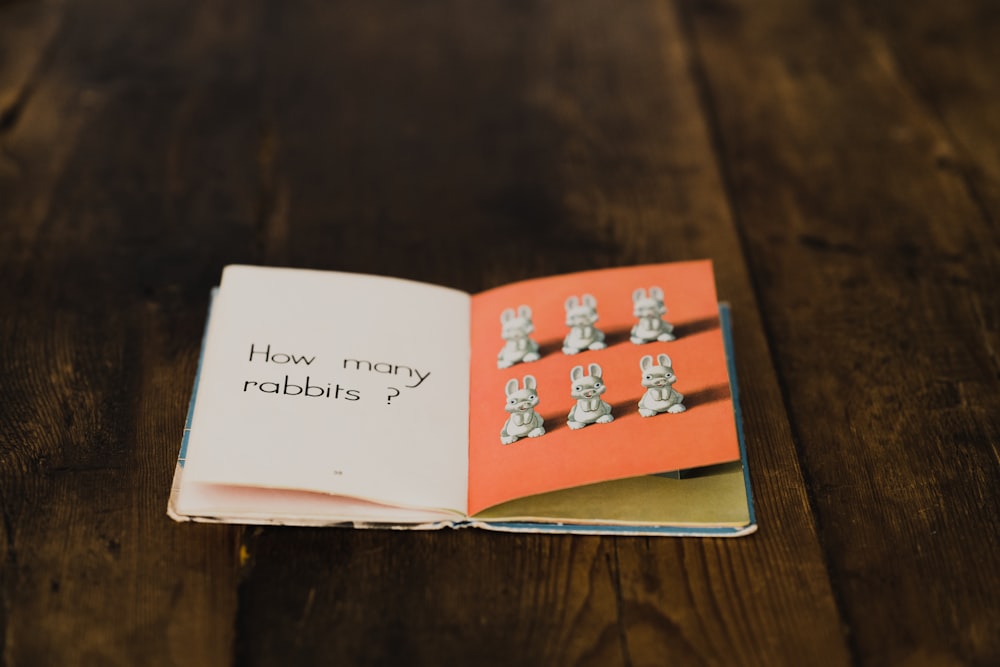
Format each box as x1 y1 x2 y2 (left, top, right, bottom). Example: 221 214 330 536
168 261 756 536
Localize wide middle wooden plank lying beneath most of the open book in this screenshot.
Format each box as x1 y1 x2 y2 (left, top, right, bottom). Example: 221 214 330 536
237 2 848 665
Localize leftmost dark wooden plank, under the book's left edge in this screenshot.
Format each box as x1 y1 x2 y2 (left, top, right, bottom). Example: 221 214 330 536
0 3 270 666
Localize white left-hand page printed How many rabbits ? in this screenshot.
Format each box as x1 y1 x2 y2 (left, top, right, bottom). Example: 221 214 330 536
181 266 470 513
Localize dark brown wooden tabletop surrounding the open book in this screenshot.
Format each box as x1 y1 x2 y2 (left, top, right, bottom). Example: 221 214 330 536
0 0 1000 667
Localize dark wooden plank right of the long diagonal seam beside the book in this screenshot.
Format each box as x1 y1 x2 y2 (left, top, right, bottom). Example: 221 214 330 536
684 1 1000 665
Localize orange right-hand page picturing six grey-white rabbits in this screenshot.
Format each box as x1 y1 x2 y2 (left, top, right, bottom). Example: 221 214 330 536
469 260 740 515
